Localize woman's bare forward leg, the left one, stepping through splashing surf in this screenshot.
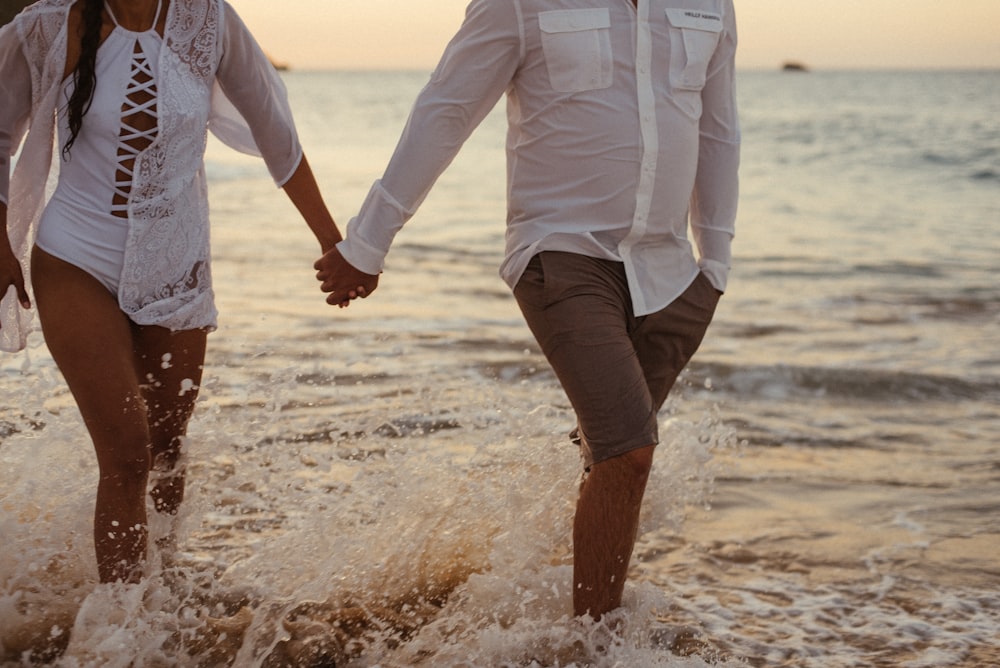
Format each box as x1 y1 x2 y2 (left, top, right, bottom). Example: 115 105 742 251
31 248 150 582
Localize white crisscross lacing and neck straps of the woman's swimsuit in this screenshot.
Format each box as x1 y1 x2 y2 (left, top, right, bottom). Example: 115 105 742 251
104 0 163 218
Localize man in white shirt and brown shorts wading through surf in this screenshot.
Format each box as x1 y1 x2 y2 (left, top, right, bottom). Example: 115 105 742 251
316 0 740 619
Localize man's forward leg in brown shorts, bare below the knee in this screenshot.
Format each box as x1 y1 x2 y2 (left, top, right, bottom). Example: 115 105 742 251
514 253 656 619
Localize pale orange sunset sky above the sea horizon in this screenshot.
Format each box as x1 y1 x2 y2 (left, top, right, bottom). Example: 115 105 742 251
230 0 1000 70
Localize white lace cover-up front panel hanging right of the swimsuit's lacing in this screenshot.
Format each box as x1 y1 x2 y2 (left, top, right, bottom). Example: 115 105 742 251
119 0 220 329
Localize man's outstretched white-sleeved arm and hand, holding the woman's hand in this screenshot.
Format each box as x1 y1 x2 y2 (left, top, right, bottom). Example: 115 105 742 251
316 0 523 304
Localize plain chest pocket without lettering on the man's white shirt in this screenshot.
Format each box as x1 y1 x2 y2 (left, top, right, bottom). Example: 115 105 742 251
538 8 612 93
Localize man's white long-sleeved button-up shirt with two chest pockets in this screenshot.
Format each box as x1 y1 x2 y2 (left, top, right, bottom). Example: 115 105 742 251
339 0 740 315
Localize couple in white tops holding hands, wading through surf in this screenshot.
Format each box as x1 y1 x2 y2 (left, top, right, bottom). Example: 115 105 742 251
0 0 740 619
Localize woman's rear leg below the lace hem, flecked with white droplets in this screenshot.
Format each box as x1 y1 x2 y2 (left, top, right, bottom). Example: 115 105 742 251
134 327 207 515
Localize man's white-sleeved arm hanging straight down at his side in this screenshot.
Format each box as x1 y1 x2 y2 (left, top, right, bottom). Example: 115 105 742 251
691 2 740 292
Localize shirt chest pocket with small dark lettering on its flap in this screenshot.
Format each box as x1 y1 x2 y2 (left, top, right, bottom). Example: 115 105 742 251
667 8 722 90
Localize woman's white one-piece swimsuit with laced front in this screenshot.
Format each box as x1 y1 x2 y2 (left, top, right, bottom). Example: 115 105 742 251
36 0 163 295
